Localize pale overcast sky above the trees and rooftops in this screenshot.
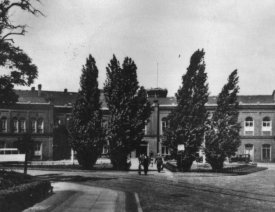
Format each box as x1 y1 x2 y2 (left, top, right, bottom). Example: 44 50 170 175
12 0 275 96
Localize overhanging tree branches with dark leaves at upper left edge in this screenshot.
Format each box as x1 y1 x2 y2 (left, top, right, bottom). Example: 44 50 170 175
0 0 42 104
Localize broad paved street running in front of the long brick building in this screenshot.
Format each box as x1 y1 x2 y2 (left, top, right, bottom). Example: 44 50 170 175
20 161 275 212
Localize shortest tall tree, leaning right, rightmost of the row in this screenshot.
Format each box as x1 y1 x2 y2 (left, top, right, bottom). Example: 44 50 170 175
204 70 241 170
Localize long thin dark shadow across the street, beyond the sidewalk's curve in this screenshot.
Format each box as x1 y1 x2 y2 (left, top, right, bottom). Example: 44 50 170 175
36 174 117 182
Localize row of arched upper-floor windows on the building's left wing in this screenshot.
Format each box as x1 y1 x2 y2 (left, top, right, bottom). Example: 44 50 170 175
0 117 44 133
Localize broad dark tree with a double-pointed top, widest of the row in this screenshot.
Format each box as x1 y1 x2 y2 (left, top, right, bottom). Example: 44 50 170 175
104 56 152 170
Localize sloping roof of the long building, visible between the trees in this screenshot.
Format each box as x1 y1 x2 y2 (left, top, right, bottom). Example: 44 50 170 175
15 90 275 108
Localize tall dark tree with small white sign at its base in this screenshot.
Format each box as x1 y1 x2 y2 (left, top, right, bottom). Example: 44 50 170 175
165 50 208 171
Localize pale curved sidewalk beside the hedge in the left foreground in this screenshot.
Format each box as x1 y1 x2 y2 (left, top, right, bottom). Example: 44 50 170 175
24 182 126 212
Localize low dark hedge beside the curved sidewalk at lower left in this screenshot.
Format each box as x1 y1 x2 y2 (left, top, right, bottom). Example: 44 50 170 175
0 181 52 212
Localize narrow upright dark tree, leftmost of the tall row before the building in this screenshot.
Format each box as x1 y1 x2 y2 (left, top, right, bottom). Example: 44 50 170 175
70 55 104 169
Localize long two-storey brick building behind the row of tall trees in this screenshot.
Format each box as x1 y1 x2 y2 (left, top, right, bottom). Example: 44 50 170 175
0 85 275 162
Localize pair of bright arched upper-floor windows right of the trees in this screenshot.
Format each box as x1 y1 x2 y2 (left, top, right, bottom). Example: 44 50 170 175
244 117 272 135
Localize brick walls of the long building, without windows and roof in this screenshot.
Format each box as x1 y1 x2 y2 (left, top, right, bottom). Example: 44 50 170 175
0 93 275 162
